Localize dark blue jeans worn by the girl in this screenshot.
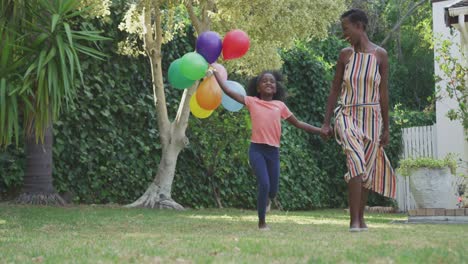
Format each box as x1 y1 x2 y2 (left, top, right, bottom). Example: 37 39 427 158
249 143 280 221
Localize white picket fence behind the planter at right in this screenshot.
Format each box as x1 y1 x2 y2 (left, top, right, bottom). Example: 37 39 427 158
396 125 437 212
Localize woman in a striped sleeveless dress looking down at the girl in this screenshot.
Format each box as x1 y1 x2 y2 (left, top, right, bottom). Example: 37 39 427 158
322 9 395 232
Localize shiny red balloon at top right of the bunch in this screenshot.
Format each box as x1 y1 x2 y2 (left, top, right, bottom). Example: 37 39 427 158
223 29 250 60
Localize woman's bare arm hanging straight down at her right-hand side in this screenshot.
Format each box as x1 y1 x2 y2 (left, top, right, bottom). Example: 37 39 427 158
377 47 390 146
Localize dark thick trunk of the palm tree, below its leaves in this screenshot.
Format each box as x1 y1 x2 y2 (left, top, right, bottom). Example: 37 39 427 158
15 122 66 205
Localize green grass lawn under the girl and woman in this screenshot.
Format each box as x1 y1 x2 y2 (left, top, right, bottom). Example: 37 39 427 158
0 204 468 263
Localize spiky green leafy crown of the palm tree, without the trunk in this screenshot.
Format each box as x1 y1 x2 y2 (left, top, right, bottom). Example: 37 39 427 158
0 0 109 145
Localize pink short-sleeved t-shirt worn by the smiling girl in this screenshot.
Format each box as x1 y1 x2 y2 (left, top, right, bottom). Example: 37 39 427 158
244 96 292 147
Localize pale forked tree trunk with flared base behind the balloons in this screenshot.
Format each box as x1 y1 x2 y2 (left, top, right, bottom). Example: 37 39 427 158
126 0 198 210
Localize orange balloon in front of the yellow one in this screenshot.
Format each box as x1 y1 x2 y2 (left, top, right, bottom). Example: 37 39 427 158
197 76 223 110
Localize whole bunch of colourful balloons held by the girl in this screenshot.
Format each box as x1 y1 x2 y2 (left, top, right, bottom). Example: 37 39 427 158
168 29 250 118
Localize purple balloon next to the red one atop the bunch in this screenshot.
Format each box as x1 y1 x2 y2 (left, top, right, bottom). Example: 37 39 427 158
197 31 223 63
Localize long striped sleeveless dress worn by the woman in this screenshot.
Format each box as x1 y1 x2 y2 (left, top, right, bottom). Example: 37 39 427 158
335 51 396 198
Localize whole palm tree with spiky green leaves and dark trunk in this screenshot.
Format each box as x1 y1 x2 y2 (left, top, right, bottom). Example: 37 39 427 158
0 0 107 204
